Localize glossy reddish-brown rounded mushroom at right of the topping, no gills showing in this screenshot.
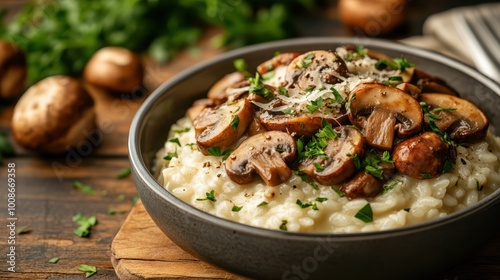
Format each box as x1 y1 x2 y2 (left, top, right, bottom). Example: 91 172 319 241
392 131 451 179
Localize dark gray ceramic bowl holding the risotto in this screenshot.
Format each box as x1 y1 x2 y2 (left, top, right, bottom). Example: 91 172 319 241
129 38 500 279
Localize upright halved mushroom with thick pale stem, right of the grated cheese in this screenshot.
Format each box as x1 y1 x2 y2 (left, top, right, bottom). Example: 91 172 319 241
349 84 424 150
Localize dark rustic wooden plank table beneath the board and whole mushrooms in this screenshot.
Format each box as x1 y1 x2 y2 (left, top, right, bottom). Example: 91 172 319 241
0 1 500 279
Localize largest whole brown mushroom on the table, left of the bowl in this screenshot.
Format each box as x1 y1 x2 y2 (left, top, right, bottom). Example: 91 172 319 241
12 76 96 154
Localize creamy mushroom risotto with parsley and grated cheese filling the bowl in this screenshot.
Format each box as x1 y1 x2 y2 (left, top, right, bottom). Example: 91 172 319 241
158 46 500 233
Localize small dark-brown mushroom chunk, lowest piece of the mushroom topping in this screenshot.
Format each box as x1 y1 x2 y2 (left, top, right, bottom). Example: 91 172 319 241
340 172 384 199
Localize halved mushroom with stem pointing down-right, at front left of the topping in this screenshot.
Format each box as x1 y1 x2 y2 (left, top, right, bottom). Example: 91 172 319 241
225 131 297 186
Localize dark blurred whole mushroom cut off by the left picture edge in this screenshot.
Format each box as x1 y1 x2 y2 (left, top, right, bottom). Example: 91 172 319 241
0 41 27 99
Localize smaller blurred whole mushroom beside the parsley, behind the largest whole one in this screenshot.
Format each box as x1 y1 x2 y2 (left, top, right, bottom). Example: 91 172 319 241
83 47 144 93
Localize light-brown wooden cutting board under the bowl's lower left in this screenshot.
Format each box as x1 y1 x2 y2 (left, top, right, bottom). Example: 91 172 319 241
111 202 245 279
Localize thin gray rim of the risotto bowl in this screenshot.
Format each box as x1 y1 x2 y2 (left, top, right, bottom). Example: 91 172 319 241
128 37 500 240
